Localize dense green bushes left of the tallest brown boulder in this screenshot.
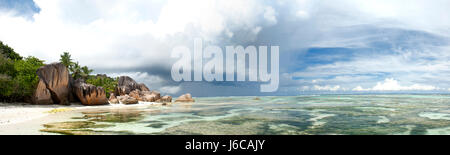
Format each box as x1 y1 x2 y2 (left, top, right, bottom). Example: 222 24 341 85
0 41 44 102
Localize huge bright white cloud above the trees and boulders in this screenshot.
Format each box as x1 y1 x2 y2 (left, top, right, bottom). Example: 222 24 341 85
0 0 277 69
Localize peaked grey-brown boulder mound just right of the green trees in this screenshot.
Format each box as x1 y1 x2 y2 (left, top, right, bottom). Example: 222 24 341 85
115 76 149 96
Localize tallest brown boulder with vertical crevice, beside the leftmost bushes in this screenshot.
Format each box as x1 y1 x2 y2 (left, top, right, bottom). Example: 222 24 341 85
33 63 71 105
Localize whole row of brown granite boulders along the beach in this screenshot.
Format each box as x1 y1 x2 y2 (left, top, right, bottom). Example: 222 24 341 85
32 63 194 105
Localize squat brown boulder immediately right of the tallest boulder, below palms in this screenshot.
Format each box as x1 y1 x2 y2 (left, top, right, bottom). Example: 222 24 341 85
73 80 109 105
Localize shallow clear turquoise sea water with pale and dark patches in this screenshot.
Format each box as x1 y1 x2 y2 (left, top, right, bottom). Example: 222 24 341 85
41 95 450 135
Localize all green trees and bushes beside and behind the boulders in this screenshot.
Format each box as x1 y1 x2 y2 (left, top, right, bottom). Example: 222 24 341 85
0 41 118 102
